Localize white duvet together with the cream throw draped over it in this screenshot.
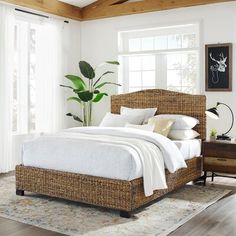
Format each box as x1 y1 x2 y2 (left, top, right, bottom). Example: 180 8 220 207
22 127 186 196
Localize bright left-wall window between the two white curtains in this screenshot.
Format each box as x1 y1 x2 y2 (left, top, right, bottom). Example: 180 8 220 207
12 17 40 134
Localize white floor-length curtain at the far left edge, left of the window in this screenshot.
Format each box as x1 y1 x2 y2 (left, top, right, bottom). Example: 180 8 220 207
0 4 14 173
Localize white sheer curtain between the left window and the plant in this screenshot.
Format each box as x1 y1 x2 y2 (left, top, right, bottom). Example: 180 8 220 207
36 19 67 133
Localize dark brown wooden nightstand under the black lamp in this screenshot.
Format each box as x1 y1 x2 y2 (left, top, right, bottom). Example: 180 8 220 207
203 141 236 183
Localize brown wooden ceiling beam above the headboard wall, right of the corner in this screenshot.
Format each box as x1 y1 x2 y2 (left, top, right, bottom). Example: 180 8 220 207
82 0 236 21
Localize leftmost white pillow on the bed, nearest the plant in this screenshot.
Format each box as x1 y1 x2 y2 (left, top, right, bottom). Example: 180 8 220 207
100 112 143 127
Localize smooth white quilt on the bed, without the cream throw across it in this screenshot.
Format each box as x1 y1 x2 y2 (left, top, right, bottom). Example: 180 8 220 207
22 128 186 185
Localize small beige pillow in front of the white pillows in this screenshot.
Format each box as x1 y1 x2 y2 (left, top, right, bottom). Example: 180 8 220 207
148 118 175 137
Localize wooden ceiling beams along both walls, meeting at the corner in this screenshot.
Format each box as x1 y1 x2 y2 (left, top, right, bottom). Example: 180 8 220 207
0 0 236 21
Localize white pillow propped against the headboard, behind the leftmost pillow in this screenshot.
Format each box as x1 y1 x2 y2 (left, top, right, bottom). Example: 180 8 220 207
120 106 157 123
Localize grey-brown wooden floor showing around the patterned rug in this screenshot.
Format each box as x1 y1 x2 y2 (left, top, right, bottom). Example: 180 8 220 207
0 171 236 236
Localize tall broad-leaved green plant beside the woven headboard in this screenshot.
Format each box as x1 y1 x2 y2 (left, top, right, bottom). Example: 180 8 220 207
60 61 121 126
